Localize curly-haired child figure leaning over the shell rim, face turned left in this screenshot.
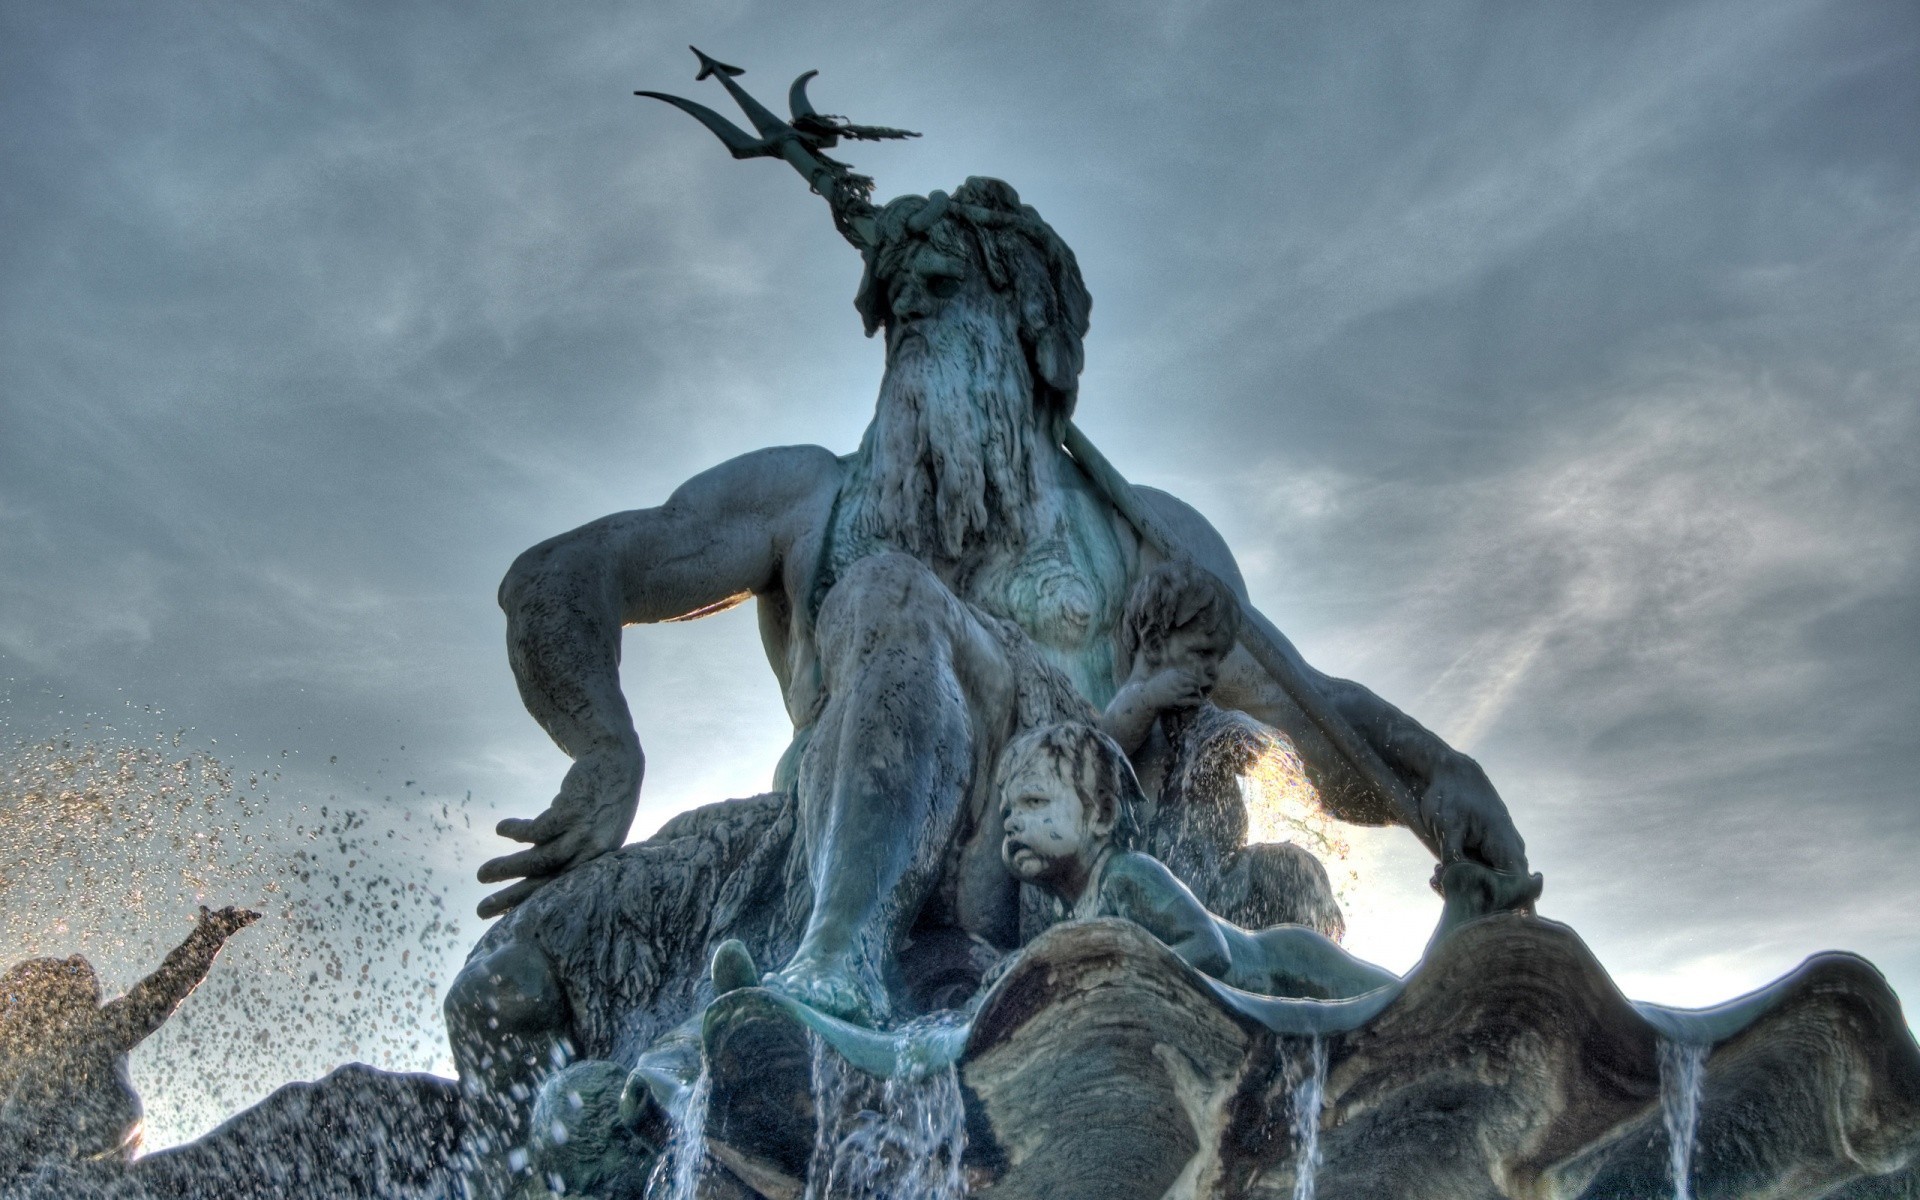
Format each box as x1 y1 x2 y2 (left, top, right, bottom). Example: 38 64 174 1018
996 722 1398 1000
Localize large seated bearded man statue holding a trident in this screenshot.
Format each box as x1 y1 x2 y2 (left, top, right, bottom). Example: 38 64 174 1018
468 56 1526 1023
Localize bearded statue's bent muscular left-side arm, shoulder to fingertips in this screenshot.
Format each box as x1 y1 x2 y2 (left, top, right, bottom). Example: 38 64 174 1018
480 445 841 916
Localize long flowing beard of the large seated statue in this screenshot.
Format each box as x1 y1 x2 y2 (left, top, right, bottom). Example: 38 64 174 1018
852 298 1039 563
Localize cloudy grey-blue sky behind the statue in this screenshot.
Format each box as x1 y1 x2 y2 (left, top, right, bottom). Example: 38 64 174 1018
0 0 1920 1140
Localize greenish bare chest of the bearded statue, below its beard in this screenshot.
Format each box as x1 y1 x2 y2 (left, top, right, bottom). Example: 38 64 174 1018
960 520 1127 705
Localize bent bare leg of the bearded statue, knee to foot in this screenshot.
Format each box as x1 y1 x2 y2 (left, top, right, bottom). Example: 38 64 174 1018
772 553 1012 1021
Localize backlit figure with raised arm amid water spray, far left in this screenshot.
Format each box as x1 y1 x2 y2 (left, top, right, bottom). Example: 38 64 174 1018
0 906 259 1179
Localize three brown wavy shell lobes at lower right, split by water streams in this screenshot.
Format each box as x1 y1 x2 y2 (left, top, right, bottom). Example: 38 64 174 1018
962 916 1920 1200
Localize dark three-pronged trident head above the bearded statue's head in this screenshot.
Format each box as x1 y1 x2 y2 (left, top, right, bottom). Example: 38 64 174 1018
634 46 920 250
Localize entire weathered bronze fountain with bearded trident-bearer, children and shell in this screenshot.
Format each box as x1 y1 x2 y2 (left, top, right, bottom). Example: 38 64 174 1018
0 44 1920 1200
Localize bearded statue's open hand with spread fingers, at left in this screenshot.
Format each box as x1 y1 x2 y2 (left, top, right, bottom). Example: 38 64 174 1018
480 741 647 918
